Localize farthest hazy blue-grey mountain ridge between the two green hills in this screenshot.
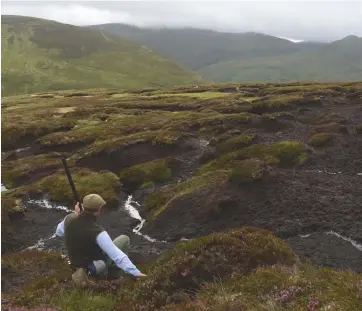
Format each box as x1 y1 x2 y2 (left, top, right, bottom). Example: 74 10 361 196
90 24 322 70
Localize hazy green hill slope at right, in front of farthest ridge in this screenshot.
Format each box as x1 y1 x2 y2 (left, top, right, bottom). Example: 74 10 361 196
200 37 362 82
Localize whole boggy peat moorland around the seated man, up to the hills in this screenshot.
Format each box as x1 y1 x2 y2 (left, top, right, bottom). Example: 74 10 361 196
1 82 362 311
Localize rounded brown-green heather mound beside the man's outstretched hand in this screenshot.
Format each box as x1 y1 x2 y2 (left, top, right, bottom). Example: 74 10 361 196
117 228 296 310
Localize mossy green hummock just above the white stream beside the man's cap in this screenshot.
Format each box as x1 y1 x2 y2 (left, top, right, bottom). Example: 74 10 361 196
120 157 179 190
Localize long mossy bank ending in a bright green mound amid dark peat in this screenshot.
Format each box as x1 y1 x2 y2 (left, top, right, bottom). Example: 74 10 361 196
196 141 308 175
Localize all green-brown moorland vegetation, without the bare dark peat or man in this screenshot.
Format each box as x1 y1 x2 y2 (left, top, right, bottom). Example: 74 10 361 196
2 82 362 311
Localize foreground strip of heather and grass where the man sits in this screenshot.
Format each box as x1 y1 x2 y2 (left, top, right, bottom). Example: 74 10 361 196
2 227 362 311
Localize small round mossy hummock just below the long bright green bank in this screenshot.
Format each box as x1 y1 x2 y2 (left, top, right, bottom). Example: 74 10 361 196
229 159 264 185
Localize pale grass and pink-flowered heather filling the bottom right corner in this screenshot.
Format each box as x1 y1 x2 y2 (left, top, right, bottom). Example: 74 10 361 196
168 264 362 311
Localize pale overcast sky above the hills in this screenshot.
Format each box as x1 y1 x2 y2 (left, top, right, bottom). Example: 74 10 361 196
1 0 362 41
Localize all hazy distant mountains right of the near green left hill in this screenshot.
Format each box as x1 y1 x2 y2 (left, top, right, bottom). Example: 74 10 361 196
91 24 362 82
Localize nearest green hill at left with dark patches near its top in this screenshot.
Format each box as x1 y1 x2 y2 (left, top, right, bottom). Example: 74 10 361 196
1 16 201 96
